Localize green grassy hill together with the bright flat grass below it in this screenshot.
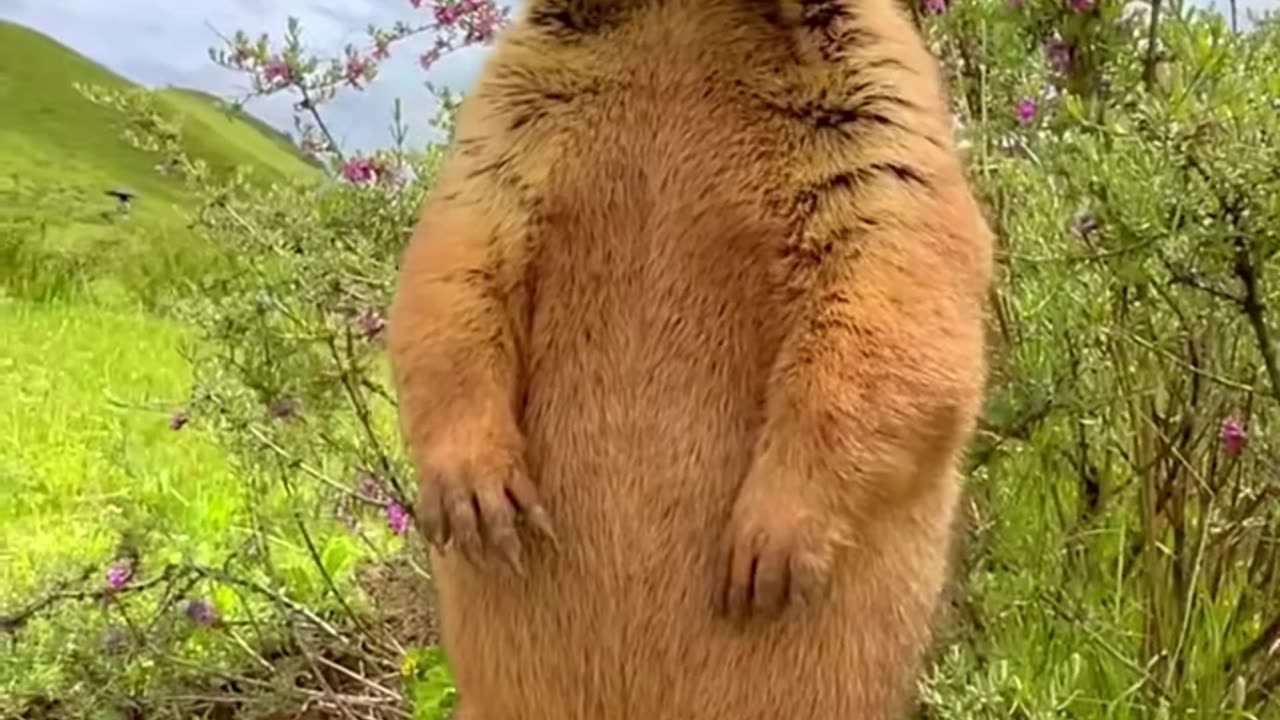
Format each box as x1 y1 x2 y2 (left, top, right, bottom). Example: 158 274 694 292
0 22 335 702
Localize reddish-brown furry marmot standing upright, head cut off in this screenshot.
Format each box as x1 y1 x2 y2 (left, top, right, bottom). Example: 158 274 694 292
389 0 992 720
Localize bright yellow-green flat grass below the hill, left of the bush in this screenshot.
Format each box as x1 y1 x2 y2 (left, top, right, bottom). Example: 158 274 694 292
0 294 241 597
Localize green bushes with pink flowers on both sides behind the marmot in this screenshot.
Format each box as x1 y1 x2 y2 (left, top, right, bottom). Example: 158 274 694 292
7 0 1280 720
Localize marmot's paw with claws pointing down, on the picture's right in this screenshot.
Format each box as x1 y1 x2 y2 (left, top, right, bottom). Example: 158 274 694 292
721 480 838 621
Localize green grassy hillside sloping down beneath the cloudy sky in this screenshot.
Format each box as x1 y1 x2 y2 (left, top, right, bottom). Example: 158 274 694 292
0 22 319 300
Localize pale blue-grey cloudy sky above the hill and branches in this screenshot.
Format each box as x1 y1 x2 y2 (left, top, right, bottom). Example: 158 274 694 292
0 0 1280 150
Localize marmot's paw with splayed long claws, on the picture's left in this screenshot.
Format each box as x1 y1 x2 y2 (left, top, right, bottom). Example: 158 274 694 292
417 423 557 574
